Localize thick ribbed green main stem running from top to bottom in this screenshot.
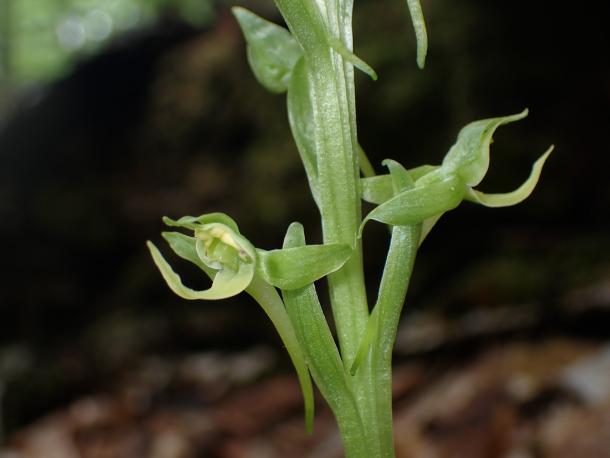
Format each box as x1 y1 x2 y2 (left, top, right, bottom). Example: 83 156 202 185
276 0 393 457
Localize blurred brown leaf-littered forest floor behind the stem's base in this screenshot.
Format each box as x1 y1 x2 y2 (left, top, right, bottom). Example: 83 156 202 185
0 274 610 458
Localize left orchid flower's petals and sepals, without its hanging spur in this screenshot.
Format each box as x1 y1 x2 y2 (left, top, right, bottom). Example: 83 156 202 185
148 213 353 300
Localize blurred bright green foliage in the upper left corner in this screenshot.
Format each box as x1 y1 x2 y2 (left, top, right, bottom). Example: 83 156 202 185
0 0 213 87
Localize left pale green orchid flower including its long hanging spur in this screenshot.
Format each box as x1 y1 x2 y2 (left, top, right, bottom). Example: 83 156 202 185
147 213 353 428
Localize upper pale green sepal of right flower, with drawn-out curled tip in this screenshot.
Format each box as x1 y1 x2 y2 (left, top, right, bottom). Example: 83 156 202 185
436 110 527 187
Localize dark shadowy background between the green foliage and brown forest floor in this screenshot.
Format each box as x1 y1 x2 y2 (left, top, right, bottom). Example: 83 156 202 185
0 0 610 431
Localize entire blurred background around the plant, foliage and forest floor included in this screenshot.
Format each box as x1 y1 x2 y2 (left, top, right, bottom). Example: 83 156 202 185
0 0 610 458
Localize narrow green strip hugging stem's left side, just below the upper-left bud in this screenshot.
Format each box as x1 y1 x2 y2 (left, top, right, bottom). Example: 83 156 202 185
287 59 319 203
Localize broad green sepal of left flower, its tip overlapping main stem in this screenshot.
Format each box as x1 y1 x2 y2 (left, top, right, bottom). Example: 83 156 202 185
257 244 353 290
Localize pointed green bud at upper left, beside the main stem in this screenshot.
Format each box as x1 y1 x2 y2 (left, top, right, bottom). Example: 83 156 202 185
232 7 303 93
